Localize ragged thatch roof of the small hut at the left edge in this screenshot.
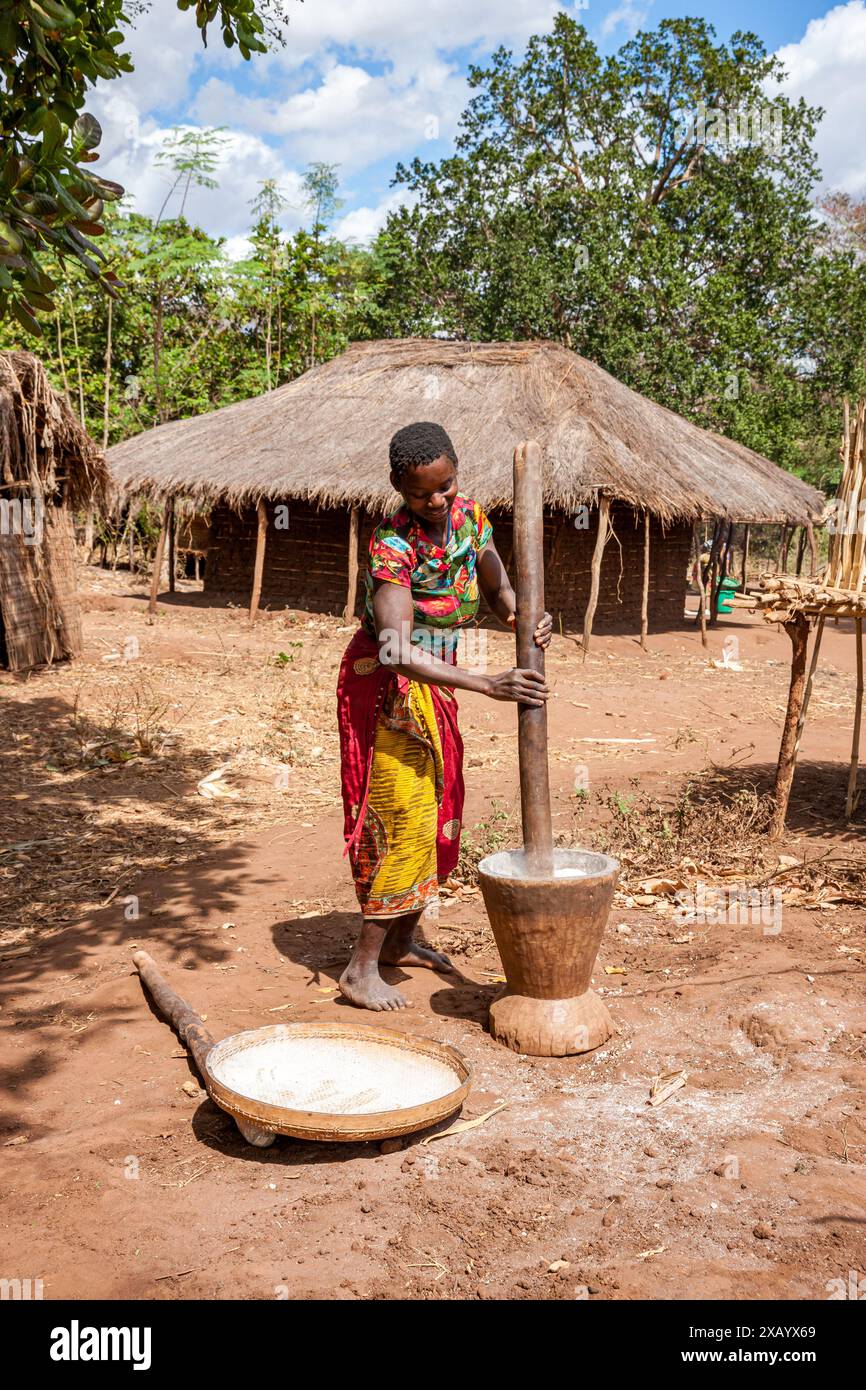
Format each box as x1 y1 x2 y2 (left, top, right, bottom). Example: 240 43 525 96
0 352 111 509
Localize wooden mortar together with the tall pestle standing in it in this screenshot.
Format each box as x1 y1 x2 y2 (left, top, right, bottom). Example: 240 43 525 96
478 441 620 1056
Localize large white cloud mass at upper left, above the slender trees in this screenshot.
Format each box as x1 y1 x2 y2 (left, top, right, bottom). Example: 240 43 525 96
88 0 559 239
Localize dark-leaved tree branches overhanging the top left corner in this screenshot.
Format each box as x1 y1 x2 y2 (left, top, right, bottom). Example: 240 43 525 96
0 0 297 334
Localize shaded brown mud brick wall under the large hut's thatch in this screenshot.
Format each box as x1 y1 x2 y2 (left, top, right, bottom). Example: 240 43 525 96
204 500 691 632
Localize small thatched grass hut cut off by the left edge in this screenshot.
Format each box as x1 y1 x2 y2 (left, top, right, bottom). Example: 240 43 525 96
0 352 108 671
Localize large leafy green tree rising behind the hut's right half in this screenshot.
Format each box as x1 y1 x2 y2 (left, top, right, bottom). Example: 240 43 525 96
378 14 862 483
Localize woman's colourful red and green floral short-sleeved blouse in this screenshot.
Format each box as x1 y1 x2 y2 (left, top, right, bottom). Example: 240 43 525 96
361 493 493 659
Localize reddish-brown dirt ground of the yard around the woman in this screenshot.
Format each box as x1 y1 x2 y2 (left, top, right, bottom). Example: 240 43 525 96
0 558 866 1300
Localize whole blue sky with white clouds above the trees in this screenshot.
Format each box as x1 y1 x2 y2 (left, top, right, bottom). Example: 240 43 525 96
89 0 866 254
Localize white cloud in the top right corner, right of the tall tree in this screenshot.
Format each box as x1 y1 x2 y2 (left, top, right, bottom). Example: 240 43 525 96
777 0 866 195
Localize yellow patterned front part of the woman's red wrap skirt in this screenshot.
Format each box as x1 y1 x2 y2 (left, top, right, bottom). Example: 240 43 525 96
353 681 443 917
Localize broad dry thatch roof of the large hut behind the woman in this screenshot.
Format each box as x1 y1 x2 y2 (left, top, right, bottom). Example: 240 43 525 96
108 338 823 523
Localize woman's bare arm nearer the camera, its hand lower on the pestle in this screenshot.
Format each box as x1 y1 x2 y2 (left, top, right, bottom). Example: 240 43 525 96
373 580 548 705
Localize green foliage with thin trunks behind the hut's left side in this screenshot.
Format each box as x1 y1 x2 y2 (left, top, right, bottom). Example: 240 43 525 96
0 146 381 442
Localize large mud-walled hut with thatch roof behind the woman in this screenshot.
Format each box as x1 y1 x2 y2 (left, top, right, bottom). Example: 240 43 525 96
108 339 823 627
